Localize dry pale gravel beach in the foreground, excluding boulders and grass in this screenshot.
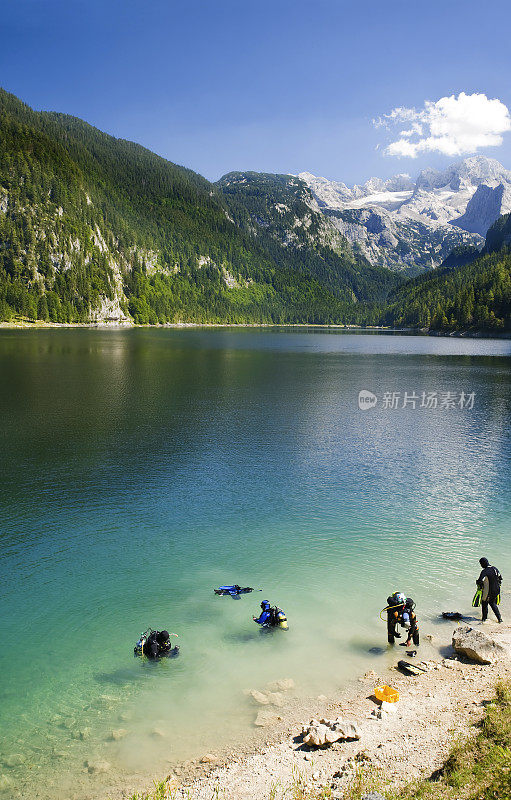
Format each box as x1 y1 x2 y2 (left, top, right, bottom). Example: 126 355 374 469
143 622 511 800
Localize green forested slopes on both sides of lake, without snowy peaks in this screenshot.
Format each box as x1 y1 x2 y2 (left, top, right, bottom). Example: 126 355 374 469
0 90 511 331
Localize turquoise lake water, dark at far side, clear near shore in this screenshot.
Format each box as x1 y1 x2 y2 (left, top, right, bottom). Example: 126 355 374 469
0 329 511 800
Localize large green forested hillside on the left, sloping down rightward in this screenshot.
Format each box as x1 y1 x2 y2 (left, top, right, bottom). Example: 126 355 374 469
0 90 399 323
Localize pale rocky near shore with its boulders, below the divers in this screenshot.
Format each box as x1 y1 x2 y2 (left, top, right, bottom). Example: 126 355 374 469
124 602 511 800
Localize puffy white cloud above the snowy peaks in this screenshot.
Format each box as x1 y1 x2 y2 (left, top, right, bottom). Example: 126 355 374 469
373 92 511 158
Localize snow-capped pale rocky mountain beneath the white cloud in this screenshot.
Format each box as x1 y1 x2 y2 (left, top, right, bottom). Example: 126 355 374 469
299 156 511 269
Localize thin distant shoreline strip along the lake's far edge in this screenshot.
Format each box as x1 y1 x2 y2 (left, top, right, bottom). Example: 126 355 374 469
0 319 511 339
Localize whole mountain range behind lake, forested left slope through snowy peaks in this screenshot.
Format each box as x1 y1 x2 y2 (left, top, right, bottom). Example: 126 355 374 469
0 90 511 327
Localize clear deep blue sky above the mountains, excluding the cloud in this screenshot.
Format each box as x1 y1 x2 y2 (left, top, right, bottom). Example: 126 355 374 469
0 0 511 184
